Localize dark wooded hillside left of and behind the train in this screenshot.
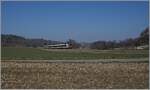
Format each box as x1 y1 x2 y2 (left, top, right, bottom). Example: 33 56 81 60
1 34 63 47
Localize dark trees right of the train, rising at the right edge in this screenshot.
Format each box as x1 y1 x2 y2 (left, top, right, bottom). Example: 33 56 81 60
90 28 149 49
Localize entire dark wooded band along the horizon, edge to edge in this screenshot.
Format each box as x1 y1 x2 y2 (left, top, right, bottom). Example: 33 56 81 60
1 28 149 50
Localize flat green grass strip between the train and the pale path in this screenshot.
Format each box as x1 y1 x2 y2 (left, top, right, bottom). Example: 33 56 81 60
1 47 148 60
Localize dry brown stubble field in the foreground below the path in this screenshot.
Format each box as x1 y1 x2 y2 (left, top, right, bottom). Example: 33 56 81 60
1 62 149 89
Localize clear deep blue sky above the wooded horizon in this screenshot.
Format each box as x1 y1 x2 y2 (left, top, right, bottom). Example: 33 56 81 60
1 1 149 42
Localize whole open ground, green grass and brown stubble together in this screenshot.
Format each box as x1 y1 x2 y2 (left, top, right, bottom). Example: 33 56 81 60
1 47 149 89
